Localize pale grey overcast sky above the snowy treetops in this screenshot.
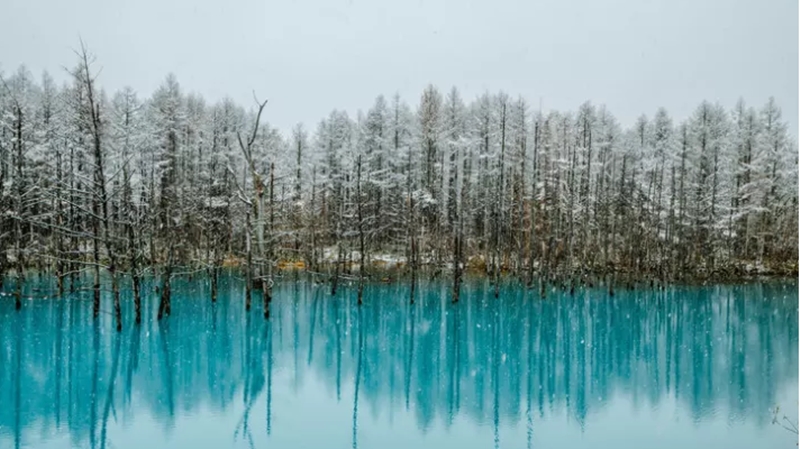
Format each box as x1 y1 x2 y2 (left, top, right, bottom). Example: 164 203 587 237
0 0 798 136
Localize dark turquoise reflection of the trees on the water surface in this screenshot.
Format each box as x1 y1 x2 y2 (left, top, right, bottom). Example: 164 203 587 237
0 274 798 447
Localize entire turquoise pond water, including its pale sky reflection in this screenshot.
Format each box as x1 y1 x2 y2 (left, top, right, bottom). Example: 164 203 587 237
0 279 798 449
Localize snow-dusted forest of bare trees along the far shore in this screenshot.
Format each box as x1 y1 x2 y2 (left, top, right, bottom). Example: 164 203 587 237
0 48 798 314
